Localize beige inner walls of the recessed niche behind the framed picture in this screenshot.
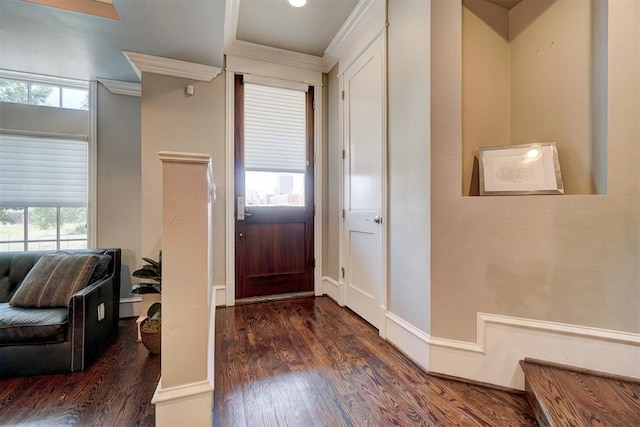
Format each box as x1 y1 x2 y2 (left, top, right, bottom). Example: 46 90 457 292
462 0 607 195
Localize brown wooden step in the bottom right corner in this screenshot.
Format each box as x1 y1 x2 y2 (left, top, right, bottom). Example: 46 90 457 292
520 358 640 427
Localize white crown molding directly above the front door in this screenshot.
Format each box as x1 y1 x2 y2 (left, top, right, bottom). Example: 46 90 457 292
225 40 325 72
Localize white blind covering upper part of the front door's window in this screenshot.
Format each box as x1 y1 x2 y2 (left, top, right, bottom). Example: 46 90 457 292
244 83 307 173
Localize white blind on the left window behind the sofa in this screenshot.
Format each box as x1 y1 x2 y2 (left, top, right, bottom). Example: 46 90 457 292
0 134 88 207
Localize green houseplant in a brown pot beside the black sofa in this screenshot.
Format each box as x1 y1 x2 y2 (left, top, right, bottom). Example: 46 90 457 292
131 250 162 354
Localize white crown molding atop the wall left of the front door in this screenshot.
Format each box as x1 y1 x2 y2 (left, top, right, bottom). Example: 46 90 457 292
122 50 222 82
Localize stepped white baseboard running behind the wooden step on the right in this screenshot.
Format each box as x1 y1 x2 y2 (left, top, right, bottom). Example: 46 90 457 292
429 313 640 390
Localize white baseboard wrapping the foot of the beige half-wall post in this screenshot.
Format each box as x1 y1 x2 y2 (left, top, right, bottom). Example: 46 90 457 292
151 378 213 427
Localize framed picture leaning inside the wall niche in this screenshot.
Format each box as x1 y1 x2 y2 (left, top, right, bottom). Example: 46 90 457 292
478 142 564 196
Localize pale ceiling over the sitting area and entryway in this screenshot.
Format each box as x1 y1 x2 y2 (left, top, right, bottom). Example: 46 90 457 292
0 0 358 82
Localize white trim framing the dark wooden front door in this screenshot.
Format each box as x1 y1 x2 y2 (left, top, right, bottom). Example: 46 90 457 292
225 69 324 306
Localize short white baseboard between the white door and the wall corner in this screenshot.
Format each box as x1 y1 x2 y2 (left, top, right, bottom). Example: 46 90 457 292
385 312 429 371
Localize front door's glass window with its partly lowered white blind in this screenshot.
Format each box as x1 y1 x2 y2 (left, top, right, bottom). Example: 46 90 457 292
244 82 307 206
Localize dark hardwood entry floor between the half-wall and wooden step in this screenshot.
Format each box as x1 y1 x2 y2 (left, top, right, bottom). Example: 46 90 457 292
213 297 535 427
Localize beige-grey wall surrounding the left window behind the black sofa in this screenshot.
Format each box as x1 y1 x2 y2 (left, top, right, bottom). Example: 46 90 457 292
0 91 142 308
